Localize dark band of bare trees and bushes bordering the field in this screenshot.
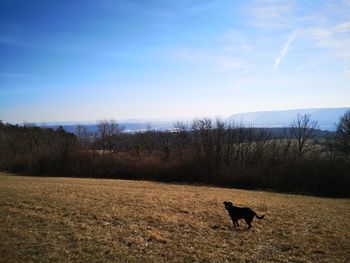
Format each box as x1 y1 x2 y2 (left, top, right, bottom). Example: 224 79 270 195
0 111 350 196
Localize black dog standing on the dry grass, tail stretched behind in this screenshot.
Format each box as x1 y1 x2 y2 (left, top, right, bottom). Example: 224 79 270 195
224 201 265 228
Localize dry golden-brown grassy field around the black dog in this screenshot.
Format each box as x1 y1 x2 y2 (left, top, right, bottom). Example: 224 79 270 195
0 174 350 262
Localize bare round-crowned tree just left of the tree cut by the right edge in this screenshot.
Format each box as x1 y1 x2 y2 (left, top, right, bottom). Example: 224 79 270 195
291 114 317 157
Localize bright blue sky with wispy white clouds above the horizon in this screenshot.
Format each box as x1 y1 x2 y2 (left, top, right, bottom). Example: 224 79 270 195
0 0 350 123
